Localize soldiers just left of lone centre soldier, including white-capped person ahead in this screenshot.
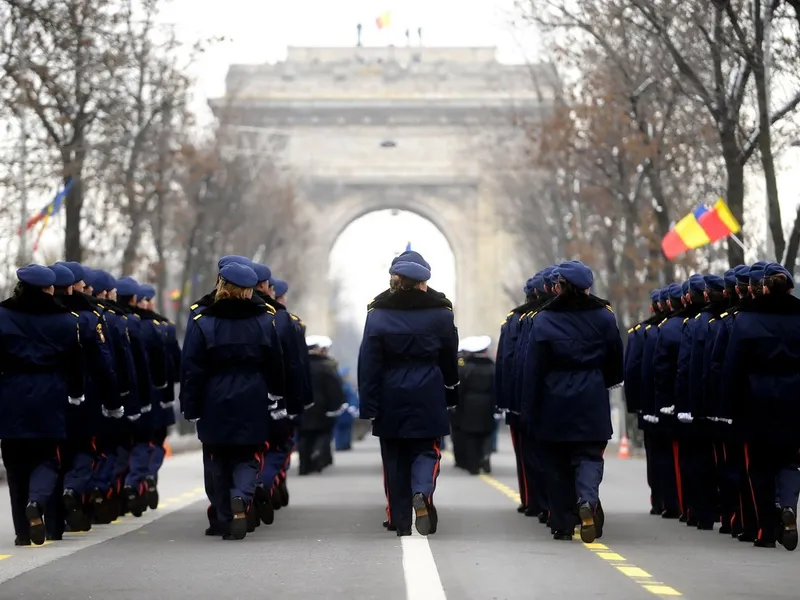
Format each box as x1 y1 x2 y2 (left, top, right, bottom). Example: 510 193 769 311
180 255 347 540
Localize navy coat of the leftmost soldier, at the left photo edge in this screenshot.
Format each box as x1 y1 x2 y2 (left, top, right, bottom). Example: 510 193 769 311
0 288 84 440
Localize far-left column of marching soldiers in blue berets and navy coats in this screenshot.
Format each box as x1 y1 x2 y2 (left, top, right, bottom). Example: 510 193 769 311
0 262 180 546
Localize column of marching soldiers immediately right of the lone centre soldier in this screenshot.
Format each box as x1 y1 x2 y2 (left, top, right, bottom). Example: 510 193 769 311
495 261 623 543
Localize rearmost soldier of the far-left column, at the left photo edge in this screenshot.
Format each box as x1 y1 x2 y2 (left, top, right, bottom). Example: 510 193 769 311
0 265 84 546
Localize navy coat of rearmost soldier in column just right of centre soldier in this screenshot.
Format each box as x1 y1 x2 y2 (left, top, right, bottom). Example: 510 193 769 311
522 294 623 442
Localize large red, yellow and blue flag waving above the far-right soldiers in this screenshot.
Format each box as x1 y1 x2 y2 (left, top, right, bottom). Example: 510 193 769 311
661 198 742 260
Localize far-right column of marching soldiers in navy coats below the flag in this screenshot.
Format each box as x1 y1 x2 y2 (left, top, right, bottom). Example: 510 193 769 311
625 262 800 550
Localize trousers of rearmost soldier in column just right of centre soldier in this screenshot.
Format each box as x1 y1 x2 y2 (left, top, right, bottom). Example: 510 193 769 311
541 442 607 532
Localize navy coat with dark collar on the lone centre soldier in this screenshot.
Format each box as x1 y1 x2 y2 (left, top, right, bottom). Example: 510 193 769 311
358 288 458 439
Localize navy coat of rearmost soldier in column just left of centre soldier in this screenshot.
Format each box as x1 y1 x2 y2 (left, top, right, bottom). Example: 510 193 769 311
181 298 285 445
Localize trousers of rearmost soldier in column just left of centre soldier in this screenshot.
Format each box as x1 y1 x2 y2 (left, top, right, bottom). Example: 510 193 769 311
208 444 261 523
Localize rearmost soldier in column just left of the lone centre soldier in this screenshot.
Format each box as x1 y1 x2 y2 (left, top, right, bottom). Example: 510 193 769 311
181 262 286 540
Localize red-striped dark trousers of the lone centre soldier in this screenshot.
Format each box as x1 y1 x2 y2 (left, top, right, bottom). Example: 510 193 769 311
381 438 442 529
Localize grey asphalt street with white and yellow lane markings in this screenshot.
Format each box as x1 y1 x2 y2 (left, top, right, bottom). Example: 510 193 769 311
0 437 800 600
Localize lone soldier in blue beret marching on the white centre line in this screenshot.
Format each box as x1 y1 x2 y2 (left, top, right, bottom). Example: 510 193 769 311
356 253 458 536
